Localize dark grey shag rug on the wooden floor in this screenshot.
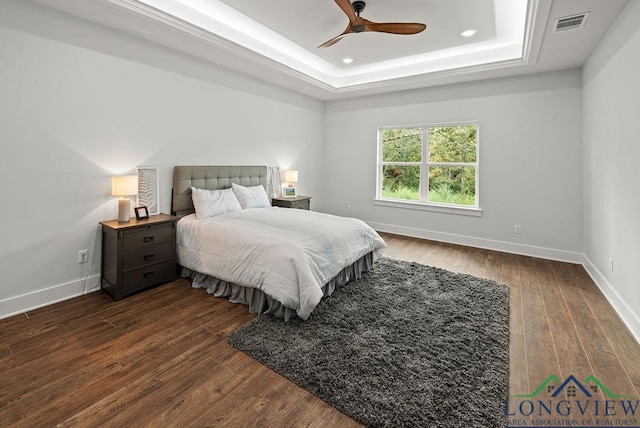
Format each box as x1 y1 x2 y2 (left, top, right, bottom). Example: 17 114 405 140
229 258 509 428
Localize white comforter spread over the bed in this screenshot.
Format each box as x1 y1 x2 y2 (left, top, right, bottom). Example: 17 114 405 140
177 207 386 319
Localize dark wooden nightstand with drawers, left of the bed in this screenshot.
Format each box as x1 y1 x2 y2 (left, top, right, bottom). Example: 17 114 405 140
100 214 178 300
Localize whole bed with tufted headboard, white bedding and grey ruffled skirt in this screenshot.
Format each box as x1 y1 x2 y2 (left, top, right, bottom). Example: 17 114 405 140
172 166 386 321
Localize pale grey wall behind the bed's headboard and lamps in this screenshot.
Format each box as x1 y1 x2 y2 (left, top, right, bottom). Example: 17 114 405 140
0 0 324 317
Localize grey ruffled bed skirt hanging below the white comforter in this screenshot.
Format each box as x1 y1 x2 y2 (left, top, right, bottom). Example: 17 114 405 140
182 252 375 321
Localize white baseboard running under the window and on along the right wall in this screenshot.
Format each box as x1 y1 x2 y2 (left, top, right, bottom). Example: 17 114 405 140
367 221 640 343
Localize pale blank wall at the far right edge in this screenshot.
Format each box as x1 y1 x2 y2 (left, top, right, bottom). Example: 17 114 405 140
583 1 640 341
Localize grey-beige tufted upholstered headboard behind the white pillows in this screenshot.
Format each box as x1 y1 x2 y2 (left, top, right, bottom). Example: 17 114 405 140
171 166 268 217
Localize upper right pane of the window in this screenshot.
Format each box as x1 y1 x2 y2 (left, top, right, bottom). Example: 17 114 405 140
429 125 478 163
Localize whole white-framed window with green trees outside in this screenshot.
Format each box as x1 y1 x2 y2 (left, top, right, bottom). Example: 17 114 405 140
377 123 478 210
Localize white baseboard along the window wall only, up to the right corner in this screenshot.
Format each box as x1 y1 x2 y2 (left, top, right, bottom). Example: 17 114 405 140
366 221 584 264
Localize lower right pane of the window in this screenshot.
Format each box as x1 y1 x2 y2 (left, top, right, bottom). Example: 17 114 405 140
427 166 476 206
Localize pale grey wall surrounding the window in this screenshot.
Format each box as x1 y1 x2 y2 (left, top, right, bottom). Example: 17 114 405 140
325 70 582 261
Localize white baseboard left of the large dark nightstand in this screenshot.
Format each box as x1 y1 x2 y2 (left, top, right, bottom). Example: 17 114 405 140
0 275 100 319
